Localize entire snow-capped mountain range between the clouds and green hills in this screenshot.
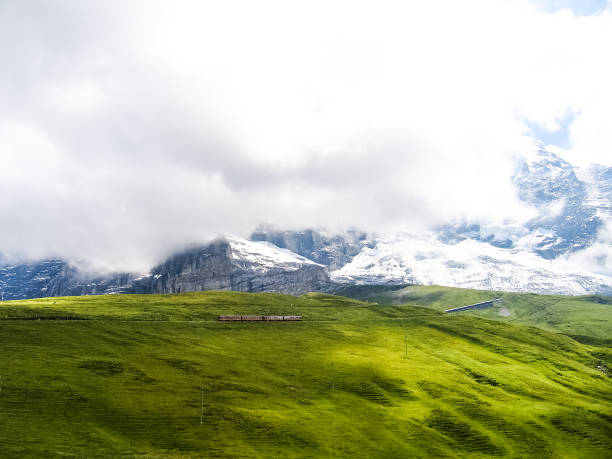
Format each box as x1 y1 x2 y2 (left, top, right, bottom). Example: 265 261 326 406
0 149 612 299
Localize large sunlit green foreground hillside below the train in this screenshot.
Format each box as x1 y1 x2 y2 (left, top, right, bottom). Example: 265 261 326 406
0 292 612 458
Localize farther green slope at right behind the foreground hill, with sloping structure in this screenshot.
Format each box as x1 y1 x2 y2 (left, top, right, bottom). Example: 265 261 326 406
339 286 612 345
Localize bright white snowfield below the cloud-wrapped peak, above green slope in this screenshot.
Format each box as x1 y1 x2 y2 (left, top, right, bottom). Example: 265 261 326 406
331 232 612 295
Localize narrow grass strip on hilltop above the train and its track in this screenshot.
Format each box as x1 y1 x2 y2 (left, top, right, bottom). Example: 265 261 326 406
0 291 437 321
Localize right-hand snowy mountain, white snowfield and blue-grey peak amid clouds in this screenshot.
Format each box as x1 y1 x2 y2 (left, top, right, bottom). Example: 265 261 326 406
331 149 612 294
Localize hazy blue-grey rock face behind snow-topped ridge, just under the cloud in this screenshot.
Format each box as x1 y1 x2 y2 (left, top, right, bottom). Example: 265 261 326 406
251 229 367 271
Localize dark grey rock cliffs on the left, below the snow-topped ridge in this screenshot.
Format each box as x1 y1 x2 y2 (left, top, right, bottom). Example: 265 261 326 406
0 239 332 300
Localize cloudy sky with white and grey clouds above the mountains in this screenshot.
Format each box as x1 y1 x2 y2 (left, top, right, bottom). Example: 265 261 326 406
0 0 612 269
